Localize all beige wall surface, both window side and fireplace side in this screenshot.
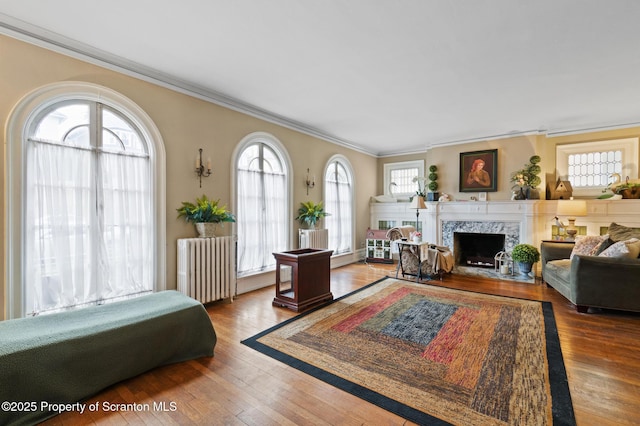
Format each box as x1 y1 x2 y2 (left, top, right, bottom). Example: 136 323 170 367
0 35 640 318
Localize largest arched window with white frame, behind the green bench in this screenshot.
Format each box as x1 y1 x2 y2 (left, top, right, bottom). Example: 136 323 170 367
5 83 165 317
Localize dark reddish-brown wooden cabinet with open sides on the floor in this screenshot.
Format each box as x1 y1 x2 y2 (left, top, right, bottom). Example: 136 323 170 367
273 248 333 312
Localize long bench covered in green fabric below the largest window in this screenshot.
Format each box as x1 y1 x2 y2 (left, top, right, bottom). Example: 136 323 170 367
0 291 216 425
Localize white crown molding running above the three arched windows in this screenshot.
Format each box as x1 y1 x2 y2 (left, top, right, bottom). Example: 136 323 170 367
0 13 378 157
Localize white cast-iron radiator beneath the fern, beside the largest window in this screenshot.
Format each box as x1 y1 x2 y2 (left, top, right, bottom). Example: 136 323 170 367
178 237 237 303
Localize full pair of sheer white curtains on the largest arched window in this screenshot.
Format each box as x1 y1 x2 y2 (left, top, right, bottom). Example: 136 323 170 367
24 141 153 315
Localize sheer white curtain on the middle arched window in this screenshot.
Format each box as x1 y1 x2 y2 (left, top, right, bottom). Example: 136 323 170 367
237 170 288 275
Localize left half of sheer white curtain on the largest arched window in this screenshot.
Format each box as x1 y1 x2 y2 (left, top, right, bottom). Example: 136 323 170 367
25 142 97 314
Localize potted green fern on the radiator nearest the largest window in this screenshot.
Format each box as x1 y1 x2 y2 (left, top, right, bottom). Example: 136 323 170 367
176 195 236 238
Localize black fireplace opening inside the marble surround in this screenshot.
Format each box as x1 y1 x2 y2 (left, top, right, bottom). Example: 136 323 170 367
453 232 505 268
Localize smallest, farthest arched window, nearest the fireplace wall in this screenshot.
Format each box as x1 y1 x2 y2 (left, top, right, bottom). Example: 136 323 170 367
324 156 354 255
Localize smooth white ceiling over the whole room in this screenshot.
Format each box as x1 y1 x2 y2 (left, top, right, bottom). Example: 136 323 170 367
0 0 640 156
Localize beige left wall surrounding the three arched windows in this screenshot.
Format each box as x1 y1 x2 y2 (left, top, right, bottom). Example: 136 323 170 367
0 35 377 318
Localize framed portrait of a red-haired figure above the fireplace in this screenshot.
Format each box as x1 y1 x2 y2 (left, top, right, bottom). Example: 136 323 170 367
459 149 498 192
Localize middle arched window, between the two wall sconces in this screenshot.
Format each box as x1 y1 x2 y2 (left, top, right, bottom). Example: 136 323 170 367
235 133 291 276
